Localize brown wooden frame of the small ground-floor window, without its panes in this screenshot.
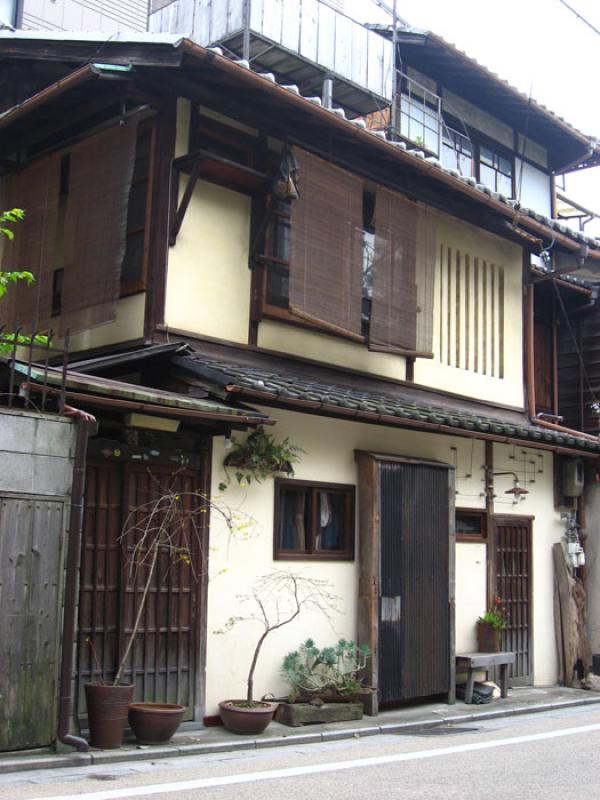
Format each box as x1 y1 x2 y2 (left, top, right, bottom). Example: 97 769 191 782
273 478 356 561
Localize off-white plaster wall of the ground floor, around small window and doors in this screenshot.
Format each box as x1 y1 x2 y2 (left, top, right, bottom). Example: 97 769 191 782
206 409 560 714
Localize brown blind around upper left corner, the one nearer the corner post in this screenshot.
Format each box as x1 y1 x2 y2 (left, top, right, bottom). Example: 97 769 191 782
62 123 137 331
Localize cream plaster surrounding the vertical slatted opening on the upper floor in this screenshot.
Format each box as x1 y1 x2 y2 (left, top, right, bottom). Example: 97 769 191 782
415 215 524 407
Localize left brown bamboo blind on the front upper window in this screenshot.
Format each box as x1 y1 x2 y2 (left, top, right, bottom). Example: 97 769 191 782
289 148 362 341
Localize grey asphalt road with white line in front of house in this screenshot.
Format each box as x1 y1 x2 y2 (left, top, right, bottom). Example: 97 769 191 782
0 706 600 800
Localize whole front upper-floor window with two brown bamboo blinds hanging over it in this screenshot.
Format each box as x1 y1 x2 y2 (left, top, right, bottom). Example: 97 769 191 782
262 145 435 355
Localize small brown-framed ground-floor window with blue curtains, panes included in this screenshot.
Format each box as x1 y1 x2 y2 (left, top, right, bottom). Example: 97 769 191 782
274 480 354 560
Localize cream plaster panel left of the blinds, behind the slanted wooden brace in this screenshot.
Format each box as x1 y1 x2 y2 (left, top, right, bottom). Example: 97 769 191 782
165 178 251 344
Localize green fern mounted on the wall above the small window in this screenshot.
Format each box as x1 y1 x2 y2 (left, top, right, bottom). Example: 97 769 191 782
219 425 305 492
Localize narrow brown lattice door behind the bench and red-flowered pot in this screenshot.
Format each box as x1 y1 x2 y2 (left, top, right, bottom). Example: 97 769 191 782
493 516 533 686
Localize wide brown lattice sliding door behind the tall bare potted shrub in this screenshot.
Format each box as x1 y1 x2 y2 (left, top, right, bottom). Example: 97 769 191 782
76 462 205 719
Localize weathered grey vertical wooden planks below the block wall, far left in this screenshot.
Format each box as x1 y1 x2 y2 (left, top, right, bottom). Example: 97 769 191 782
0 494 65 750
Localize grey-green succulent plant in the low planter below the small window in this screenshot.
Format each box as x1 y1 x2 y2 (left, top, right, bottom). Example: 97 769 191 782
281 639 371 702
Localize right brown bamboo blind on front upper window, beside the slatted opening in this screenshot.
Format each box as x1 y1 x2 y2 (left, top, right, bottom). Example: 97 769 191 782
369 186 436 356
